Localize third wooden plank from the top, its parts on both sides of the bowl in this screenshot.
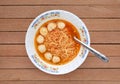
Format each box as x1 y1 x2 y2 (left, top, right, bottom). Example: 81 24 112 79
0 19 120 31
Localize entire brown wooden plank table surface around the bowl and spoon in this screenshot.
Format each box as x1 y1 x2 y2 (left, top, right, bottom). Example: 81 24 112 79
0 0 120 84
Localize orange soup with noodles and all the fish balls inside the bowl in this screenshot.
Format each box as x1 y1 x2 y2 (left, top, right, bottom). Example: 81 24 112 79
34 19 80 65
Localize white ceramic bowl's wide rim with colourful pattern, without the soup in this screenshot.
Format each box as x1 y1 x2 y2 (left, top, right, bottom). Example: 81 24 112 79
25 10 90 75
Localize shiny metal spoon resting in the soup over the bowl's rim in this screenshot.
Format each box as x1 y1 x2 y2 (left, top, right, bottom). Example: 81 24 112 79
74 36 109 62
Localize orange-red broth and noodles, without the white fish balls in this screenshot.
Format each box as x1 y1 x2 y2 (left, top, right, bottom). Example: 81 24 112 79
34 19 81 65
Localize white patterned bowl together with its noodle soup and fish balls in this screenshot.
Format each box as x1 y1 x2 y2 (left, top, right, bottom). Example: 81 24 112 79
25 10 90 75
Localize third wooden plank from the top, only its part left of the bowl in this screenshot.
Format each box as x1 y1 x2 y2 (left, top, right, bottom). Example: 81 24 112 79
0 19 33 31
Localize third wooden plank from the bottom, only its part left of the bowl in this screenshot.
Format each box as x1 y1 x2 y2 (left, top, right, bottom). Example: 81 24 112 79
0 57 35 68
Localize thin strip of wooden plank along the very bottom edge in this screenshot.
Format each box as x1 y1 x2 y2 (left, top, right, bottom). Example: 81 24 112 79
0 80 120 84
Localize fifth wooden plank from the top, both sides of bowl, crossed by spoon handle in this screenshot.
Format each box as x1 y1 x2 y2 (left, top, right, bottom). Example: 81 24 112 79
0 45 120 57
